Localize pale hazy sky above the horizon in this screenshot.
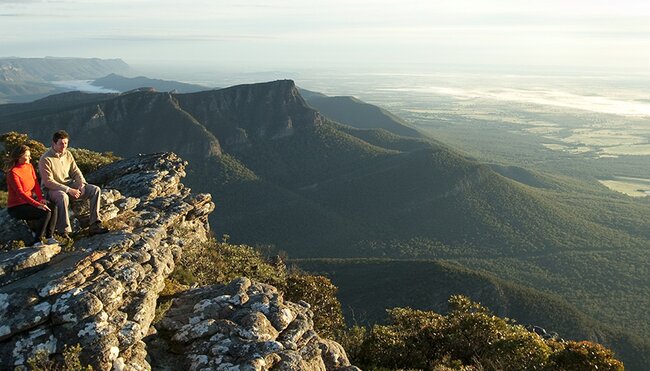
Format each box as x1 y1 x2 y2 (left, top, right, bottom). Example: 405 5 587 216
0 0 650 74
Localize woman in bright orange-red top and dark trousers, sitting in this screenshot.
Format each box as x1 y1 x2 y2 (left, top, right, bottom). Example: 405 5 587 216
5 145 58 246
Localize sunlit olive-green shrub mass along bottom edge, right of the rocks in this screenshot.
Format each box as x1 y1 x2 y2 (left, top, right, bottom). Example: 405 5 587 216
342 295 623 371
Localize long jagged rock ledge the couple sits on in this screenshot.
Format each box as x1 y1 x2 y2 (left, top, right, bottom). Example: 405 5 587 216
0 153 214 370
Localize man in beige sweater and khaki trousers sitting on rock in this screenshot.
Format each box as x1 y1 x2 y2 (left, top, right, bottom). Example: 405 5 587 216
38 130 108 237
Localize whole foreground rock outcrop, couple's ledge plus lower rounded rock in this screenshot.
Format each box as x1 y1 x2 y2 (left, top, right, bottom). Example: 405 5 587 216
0 153 350 370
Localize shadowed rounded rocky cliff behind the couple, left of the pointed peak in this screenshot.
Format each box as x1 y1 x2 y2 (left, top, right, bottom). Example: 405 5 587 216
0 91 221 162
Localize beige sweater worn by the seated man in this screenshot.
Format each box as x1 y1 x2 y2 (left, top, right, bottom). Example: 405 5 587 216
38 148 86 192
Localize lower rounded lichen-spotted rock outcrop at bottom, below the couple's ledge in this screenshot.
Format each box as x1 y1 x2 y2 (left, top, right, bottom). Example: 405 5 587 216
147 277 359 371
